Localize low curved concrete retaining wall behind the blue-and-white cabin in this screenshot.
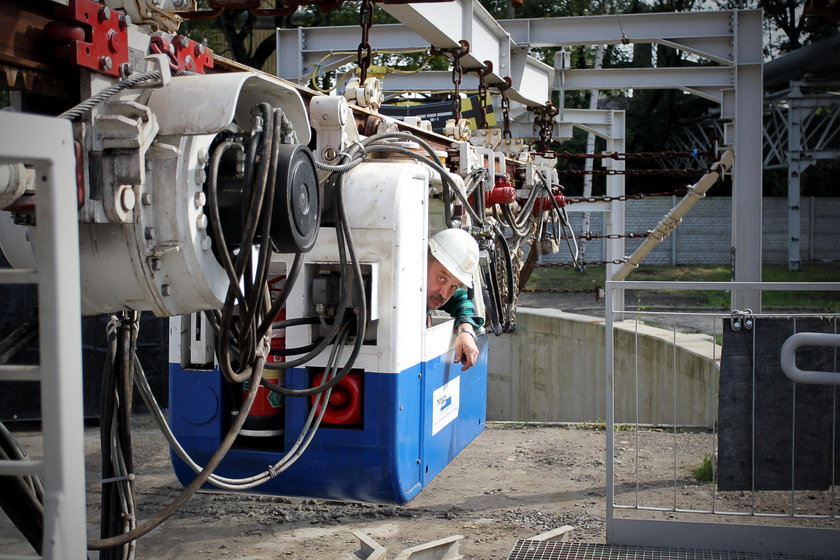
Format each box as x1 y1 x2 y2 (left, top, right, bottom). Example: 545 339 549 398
487 308 720 426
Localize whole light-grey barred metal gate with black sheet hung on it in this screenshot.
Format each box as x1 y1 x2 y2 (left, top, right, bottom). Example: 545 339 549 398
606 282 840 556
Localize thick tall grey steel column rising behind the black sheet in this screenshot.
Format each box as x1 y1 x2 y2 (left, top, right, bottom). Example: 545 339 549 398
730 11 763 313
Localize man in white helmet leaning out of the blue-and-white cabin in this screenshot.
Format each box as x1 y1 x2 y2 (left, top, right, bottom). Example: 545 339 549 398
426 228 484 371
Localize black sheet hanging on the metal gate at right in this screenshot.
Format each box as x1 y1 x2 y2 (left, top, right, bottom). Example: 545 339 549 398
718 317 840 491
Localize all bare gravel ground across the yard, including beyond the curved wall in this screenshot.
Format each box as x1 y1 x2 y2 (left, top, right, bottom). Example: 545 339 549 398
0 294 840 560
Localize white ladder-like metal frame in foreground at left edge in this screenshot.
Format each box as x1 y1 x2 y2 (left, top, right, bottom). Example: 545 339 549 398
0 111 87 560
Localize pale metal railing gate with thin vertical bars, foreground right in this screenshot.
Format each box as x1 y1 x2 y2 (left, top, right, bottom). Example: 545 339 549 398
605 281 840 556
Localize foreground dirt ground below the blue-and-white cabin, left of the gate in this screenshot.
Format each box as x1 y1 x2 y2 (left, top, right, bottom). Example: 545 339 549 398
0 418 604 560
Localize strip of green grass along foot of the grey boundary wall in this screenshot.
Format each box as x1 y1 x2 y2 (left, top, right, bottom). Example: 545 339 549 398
528 262 840 313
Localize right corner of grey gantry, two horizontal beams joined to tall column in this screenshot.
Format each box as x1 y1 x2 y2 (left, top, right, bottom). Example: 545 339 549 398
502 10 763 310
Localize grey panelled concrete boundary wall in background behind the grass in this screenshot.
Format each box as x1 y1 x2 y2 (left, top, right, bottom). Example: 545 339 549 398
540 196 840 265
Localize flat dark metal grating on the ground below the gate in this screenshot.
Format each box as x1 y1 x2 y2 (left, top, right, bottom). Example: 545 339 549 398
507 540 826 560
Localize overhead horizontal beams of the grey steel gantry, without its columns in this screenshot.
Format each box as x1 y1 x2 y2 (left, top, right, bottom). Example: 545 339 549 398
284 8 760 106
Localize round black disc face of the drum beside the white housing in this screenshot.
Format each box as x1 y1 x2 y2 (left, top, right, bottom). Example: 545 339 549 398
271 144 321 253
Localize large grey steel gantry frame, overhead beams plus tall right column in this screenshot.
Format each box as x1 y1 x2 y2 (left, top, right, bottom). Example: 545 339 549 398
277 6 763 312
